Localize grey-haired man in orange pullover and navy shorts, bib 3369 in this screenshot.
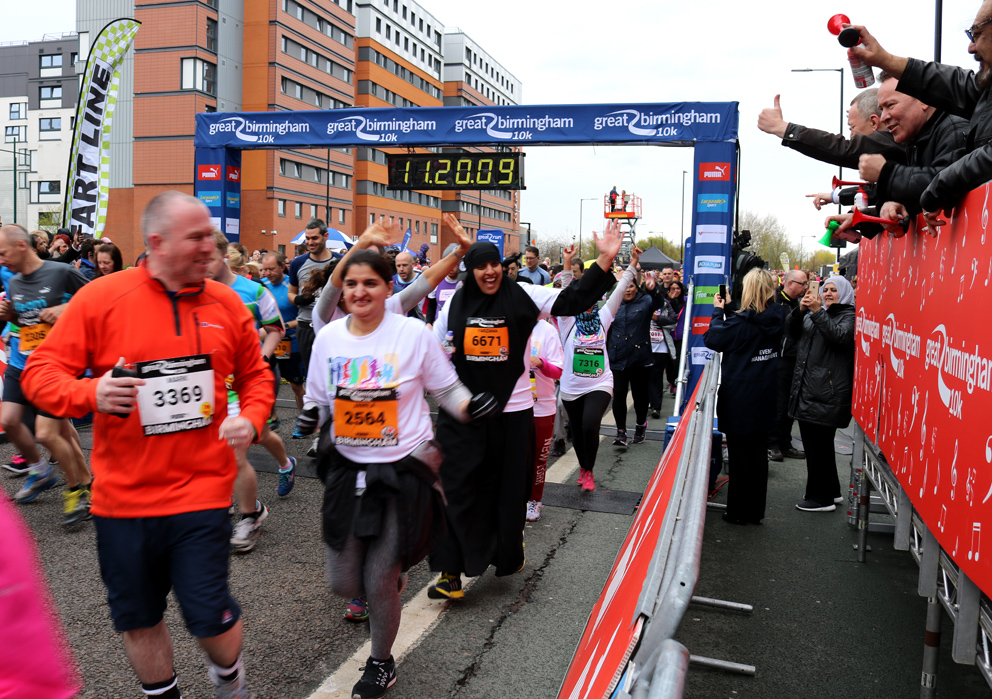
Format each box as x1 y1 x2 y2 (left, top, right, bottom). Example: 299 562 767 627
21 191 274 699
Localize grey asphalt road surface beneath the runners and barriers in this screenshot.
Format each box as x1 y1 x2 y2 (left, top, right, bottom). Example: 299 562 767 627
0 389 992 699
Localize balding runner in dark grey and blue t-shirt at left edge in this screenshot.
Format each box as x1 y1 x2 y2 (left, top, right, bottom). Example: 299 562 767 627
0 224 93 526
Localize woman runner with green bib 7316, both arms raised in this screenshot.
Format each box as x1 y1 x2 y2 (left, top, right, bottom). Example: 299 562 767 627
558 245 641 492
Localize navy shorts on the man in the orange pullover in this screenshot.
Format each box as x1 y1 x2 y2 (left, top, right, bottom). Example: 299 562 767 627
93 509 241 638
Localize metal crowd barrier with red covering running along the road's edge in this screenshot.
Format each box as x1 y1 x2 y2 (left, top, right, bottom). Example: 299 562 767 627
558 354 754 699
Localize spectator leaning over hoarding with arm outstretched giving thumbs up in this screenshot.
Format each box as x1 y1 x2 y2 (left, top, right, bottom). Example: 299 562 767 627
758 88 906 169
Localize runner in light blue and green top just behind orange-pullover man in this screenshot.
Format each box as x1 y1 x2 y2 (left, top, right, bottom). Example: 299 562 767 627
211 238 296 553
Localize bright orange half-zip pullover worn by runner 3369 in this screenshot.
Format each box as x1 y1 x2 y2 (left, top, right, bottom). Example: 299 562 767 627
21 265 275 517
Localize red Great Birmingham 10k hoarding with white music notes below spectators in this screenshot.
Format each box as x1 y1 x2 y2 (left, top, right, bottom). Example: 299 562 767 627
854 183 992 595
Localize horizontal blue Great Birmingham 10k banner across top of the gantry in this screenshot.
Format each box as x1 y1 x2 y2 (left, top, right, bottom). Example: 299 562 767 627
194 102 737 148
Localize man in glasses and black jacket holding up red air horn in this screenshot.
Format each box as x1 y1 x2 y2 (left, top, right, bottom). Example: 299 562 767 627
851 6 992 231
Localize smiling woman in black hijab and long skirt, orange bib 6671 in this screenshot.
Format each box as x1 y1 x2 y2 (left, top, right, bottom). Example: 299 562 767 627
428 214 620 599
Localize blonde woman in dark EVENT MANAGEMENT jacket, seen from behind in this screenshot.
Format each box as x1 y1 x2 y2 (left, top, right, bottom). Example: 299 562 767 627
703 269 786 524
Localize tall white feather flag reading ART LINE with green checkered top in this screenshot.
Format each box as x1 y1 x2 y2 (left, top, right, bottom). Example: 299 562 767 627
62 18 141 238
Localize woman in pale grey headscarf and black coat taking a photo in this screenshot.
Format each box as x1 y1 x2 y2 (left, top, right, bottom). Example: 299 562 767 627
789 276 854 512
